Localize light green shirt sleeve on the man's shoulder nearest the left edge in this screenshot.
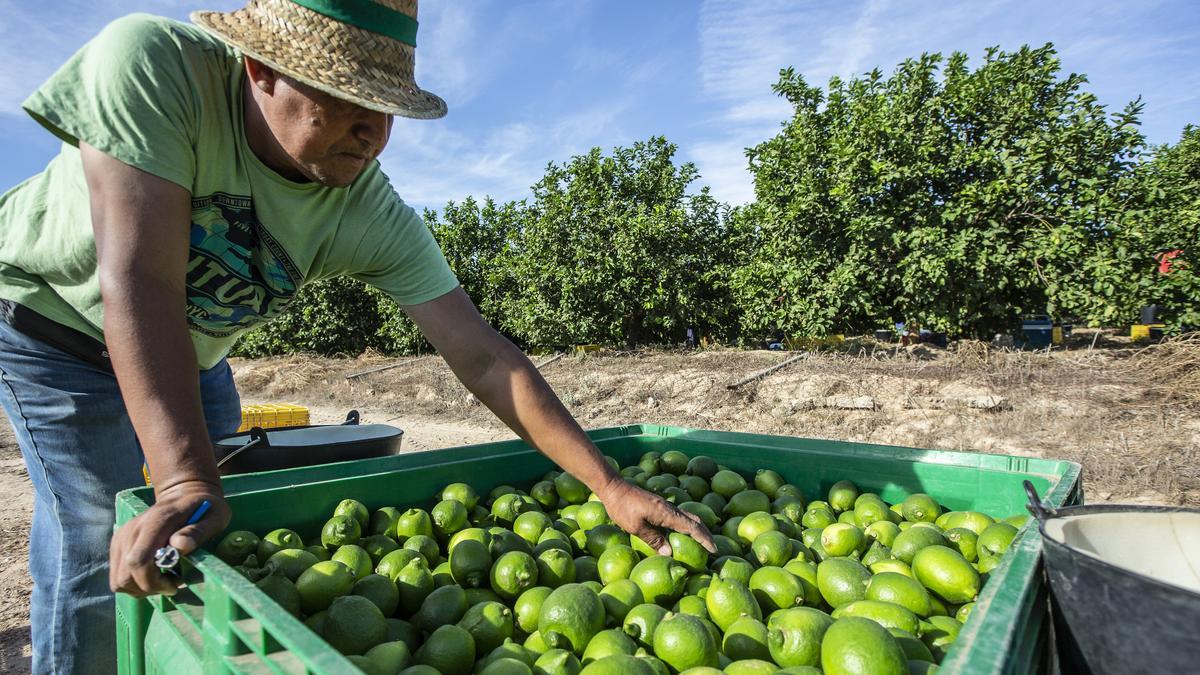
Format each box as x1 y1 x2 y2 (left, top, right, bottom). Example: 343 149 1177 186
22 14 199 190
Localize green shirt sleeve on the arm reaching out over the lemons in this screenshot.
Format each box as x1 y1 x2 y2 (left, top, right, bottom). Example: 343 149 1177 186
350 183 458 305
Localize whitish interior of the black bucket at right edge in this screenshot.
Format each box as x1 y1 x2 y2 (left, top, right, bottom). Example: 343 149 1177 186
1045 512 1200 593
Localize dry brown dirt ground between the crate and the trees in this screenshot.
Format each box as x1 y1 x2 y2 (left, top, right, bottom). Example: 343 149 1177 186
0 333 1200 673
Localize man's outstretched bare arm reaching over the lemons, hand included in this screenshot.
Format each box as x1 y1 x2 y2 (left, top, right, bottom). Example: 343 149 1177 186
404 283 716 554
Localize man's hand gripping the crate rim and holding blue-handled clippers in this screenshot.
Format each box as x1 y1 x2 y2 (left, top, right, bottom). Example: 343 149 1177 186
108 480 230 597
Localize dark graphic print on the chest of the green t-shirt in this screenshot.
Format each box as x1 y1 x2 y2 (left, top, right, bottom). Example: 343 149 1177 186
187 192 302 338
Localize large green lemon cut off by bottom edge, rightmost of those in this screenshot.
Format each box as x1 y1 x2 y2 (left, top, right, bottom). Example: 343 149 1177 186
821 616 908 675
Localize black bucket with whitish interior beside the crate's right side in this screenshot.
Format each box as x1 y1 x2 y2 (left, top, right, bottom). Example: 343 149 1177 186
1025 480 1200 675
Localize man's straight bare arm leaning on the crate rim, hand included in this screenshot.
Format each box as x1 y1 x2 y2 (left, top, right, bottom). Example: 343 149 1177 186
79 143 229 596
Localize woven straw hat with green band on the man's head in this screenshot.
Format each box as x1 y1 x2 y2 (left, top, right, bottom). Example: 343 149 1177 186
191 0 446 119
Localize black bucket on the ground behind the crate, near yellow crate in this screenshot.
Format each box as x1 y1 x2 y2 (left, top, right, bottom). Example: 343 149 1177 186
214 411 404 474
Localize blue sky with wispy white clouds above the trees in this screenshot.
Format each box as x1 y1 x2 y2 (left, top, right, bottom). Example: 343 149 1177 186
0 0 1200 208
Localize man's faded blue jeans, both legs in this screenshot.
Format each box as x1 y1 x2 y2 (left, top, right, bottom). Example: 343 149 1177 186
0 321 241 674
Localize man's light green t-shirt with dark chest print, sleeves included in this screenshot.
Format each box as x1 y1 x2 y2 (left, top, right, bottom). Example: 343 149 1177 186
0 14 457 368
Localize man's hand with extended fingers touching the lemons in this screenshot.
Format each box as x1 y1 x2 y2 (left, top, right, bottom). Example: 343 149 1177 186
598 479 716 555
